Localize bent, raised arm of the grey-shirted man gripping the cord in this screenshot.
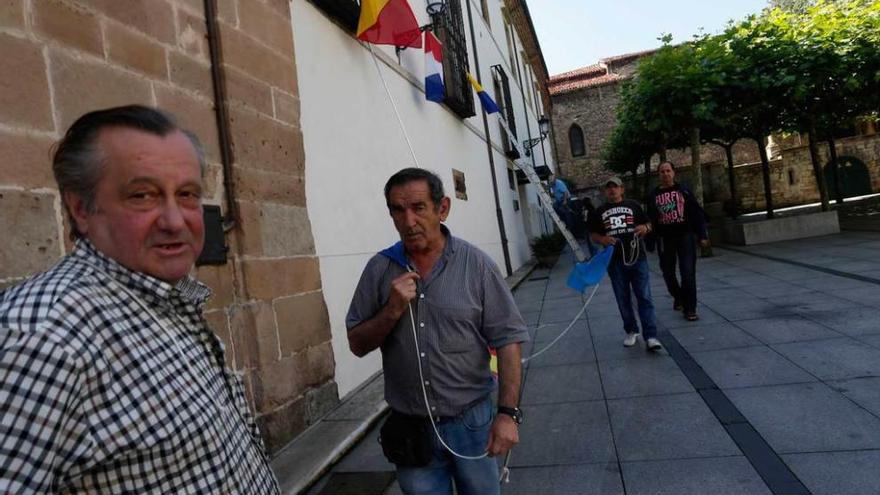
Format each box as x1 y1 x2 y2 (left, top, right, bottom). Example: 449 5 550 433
348 272 419 357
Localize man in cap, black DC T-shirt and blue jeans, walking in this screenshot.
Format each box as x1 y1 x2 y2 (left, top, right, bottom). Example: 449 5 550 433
590 177 663 351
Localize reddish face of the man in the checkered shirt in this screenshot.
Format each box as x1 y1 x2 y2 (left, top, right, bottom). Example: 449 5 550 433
65 127 205 284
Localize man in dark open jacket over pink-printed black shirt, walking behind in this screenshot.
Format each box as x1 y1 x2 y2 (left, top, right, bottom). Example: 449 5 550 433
648 162 709 321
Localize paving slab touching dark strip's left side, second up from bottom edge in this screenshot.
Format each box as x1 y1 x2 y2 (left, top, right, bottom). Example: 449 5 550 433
608 393 740 462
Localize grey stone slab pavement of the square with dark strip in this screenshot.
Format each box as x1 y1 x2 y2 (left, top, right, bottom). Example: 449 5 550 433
309 232 880 495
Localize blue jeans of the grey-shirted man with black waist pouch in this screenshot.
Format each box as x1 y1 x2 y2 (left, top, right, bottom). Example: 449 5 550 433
397 397 501 495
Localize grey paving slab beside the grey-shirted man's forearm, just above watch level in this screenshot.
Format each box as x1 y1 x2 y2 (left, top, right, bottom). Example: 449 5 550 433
522 363 602 406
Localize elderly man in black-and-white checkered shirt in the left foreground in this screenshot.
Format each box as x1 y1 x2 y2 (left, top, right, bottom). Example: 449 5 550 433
0 106 279 494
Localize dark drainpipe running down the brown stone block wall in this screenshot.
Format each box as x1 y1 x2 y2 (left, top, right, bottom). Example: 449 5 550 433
205 0 238 232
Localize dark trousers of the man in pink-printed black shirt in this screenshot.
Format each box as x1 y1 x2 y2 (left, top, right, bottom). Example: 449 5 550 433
657 233 697 313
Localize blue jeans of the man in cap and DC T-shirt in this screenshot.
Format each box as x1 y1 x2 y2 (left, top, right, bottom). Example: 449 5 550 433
608 259 657 339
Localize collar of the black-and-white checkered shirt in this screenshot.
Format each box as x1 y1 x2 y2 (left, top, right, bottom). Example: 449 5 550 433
71 238 211 308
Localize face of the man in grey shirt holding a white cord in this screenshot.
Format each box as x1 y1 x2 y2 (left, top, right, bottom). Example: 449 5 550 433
388 180 450 253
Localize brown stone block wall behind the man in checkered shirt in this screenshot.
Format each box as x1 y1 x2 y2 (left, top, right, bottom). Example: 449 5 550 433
0 0 338 456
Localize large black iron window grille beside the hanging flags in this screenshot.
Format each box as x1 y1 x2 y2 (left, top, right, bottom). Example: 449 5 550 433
431 0 476 118
